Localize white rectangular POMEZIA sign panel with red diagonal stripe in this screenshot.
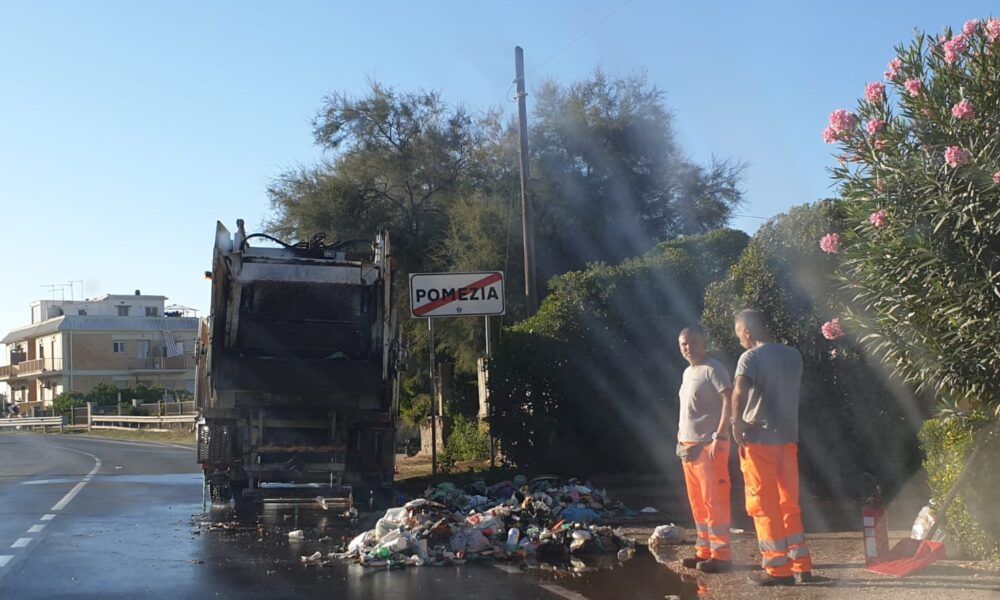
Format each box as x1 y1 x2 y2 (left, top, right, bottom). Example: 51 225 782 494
410 271 504 318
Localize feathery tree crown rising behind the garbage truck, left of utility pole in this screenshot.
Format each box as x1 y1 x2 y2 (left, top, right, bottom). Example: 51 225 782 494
269 83 482 273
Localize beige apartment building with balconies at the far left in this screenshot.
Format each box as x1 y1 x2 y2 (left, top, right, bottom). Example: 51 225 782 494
0 290 199 414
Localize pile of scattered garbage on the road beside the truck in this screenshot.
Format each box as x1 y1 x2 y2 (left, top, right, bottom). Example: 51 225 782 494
324 476 635 569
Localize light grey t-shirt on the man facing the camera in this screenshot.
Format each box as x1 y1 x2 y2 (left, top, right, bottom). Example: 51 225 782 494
677 357 733 443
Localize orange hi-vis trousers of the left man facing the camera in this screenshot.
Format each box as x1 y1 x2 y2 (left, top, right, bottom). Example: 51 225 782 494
681 442 733 560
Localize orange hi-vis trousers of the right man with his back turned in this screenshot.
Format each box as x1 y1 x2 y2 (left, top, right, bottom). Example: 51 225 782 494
740 444 812 577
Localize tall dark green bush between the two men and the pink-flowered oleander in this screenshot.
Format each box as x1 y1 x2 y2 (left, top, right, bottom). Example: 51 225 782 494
702 201 924 500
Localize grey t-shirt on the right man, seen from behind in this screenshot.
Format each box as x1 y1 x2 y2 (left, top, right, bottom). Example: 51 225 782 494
736 342 802 444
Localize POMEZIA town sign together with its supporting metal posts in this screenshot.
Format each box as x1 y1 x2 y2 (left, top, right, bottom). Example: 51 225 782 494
410 271 506 475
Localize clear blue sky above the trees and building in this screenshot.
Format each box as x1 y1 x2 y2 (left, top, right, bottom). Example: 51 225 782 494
0 0 995 346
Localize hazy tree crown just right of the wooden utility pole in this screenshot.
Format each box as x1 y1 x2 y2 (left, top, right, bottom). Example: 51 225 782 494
531 69 742 275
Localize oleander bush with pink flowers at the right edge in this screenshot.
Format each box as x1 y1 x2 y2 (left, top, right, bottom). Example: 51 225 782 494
825 19 1000 409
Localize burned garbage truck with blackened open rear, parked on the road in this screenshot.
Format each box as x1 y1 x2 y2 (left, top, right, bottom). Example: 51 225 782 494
197 221 397 508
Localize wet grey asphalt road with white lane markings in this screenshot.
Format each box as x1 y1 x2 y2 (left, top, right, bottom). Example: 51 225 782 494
0 434 697 600
